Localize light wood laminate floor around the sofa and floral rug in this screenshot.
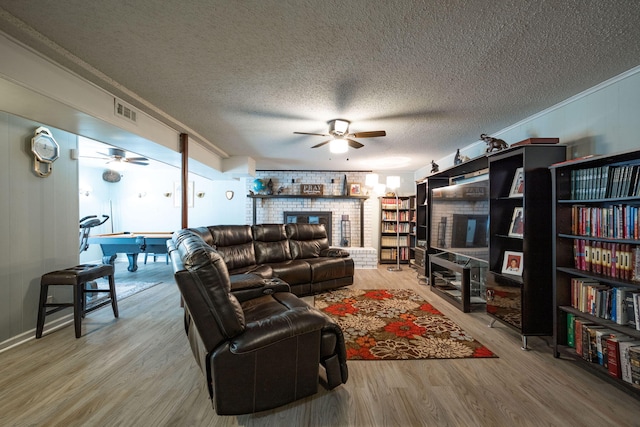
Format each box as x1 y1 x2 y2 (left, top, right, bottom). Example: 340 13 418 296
0 263 640 427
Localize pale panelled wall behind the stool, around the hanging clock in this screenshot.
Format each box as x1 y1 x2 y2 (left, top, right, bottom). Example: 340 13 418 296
0 112 78 348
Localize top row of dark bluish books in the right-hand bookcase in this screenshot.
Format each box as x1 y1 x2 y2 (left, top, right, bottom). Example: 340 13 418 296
571 165 640 200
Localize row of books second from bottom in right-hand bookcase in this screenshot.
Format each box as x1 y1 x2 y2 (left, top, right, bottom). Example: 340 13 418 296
571 277 640 330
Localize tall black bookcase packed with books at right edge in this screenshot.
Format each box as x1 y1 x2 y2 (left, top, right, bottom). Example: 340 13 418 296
551 151 640 397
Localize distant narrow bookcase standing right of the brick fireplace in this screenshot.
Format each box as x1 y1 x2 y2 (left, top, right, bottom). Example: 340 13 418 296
380 196 416 264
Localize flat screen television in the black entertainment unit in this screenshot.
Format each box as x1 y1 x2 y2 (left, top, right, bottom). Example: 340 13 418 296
429 177 489 262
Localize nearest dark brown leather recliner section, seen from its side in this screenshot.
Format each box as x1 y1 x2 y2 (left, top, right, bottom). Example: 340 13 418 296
167 230 348 415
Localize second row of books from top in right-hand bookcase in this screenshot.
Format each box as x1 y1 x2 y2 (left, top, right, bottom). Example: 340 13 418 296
571 204 640 240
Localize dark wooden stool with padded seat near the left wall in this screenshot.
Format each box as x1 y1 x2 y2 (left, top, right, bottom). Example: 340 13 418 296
36 264 118 338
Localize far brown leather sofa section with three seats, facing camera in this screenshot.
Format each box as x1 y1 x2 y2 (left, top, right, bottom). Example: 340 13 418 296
185 224 354 296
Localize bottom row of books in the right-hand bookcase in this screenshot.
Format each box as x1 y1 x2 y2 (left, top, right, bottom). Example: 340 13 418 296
567 314 640 387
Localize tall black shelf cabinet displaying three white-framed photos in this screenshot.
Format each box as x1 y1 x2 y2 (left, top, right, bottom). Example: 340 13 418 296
487 144 566 349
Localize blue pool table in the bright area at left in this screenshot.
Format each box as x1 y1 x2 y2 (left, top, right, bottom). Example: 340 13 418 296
87 231 172 272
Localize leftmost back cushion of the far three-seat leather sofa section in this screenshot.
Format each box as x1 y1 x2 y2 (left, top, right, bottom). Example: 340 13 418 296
207 225 256 270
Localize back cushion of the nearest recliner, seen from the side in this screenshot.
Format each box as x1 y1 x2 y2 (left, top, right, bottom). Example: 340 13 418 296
174 234 245 342
